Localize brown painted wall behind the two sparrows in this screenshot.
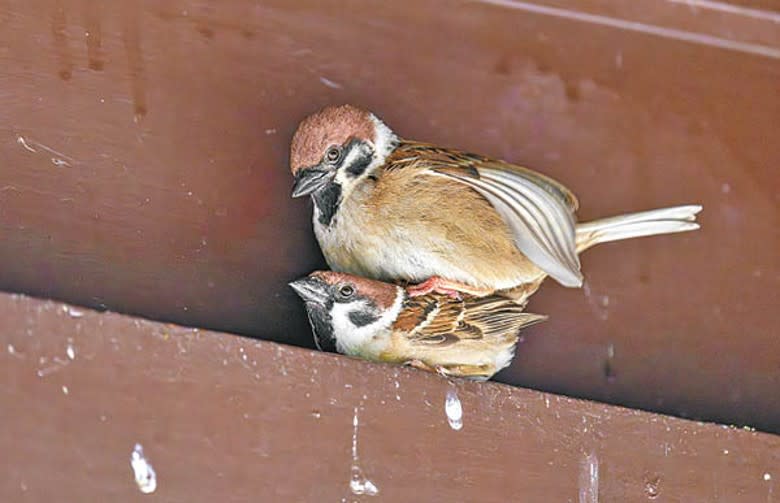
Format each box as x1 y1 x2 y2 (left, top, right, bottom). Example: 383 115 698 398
0 0 780 431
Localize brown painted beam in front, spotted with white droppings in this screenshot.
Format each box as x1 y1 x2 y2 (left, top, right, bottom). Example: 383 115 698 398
0 295 780 503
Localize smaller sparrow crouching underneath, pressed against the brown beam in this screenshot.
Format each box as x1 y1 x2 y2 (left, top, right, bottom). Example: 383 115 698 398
290 271 546 380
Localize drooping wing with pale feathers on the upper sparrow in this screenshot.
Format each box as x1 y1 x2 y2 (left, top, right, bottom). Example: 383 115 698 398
388 142 582 287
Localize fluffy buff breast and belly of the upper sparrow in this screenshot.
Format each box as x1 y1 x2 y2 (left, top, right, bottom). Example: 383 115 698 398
314 169 539 289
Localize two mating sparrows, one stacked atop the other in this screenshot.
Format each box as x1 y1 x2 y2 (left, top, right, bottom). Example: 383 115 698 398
290 105 701 379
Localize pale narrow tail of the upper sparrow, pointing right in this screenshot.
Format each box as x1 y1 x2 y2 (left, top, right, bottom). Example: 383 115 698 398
577 205 702 252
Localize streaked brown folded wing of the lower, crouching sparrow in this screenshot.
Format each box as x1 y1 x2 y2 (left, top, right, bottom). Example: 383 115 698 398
393 294 547 347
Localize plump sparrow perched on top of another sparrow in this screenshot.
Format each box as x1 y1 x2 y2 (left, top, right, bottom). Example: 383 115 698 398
290 105 702 297
